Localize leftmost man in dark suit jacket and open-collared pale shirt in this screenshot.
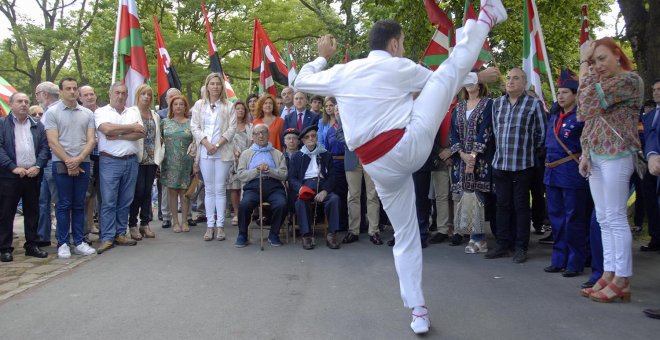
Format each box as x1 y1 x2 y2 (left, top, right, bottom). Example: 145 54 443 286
0 92 50 262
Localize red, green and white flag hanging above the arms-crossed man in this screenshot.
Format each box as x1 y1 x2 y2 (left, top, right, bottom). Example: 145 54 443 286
118 0 149 107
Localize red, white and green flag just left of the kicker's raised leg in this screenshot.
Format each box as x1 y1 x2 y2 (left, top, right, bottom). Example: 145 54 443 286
419 0 456 71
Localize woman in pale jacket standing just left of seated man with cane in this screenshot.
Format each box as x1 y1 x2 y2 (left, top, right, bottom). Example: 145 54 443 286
227 100 253 225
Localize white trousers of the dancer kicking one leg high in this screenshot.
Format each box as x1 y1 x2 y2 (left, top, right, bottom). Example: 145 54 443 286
364 20 489 308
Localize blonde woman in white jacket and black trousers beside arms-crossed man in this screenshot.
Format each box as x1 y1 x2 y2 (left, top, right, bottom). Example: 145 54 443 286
128 84 163 241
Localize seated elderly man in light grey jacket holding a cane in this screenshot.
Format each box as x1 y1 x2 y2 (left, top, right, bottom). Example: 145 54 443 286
234 124 287 248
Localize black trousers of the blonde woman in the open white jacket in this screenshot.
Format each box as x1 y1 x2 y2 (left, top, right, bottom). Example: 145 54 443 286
128 164 158 227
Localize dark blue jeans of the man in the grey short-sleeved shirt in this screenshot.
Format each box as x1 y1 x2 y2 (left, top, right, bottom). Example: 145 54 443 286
52 161 90 248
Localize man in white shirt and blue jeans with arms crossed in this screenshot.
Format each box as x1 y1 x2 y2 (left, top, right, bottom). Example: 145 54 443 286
94 82 145 254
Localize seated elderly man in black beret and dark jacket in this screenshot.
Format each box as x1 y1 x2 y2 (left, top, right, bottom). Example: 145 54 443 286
289 125 339 250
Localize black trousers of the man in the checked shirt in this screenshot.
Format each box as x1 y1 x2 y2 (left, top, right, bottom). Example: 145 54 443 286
493 168 534 250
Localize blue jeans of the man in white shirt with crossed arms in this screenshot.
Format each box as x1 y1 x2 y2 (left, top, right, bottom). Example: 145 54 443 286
99 156 138 241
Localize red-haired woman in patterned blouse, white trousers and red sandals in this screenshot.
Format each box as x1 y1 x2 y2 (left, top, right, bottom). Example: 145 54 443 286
577 37 644 302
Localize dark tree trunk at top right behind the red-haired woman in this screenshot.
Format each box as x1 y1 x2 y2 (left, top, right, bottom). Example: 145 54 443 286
618 0 660 98
